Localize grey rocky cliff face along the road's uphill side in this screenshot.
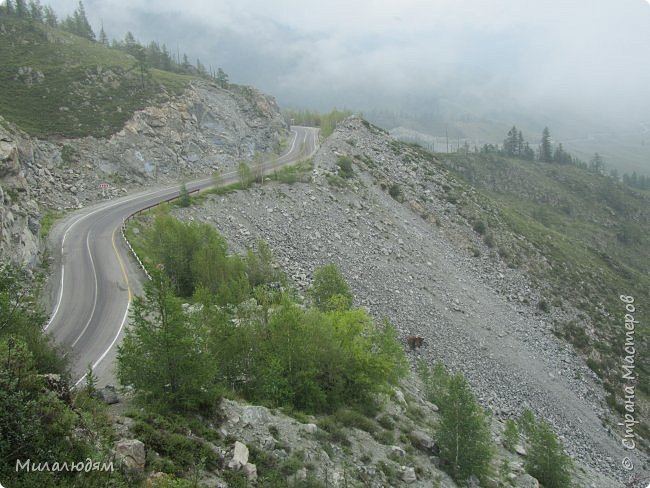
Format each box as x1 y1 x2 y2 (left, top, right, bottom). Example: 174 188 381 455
0 81 287 265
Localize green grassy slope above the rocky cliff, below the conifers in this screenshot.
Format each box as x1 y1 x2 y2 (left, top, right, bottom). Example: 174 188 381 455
0 16 191 137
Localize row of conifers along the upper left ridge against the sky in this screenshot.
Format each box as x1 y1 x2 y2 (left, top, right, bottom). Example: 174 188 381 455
0 0 228 87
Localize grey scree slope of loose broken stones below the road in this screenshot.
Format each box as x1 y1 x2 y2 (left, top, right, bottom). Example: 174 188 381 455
176 118 647 487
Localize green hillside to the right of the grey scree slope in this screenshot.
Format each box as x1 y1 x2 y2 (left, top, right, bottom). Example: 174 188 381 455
432 150 650 416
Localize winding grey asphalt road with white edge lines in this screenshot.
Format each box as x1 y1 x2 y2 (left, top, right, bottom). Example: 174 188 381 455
45 127 318 386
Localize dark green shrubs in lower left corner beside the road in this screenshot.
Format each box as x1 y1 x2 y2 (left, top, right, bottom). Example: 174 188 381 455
0 263 129 488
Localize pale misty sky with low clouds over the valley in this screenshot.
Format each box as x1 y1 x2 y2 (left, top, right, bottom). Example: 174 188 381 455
45 0 650 132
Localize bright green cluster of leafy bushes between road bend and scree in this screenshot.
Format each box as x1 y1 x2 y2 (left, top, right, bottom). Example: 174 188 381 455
118 214 407 412
